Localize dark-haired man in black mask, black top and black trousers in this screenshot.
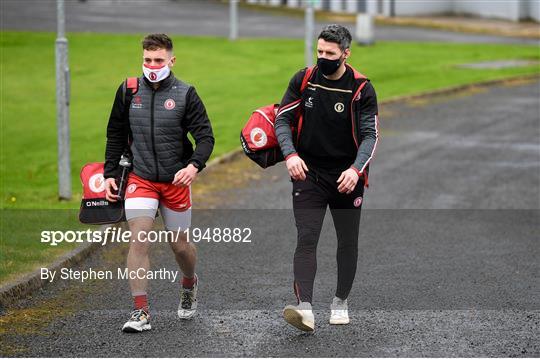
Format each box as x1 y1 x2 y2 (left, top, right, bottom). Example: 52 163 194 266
275 25 378 331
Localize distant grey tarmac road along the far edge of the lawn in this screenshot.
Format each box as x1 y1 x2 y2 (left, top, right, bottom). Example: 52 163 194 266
0 0 540 45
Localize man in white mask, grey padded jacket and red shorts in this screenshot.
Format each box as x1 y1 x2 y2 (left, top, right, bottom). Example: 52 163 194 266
104 34 214 332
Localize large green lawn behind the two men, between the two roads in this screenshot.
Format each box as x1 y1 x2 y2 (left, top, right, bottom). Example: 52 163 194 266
0 32 540 280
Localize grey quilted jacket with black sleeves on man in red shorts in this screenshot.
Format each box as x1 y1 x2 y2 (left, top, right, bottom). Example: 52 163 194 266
104 74 214 182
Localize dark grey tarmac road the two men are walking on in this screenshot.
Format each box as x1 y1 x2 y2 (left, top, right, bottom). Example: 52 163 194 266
0 80 540 357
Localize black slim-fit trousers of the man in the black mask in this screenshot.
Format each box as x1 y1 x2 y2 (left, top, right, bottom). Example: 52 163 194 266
292 168 364 303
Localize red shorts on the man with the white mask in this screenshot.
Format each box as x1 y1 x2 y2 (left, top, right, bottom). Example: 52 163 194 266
125 172 191 212
